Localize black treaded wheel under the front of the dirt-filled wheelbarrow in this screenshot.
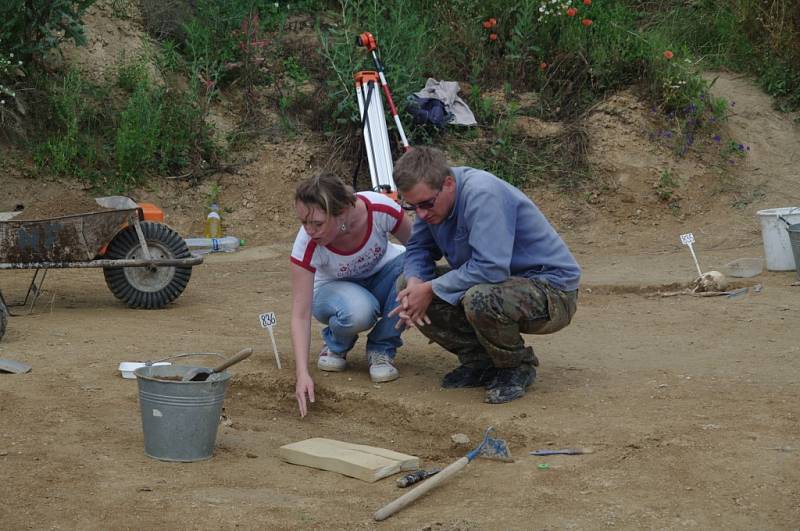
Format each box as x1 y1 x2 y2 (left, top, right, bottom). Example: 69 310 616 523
103 222 192 310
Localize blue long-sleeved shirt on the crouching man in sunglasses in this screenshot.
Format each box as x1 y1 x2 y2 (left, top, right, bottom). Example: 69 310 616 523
405 167 581 304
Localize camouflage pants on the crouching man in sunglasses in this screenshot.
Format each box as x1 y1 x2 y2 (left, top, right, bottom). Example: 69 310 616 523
397 267 578 368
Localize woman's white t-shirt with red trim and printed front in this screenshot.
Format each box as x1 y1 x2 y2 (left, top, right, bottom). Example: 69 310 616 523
290 192 405 290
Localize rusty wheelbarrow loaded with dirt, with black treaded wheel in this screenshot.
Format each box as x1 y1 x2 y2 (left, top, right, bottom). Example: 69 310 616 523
0 196 203 337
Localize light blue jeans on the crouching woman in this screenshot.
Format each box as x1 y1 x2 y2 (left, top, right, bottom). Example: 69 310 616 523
311 254 404 358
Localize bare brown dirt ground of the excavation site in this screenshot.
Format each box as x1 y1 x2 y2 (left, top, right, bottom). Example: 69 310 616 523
0 4 800 530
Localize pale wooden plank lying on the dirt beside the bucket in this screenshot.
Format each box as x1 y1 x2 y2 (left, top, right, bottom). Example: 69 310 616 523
280 437 419 483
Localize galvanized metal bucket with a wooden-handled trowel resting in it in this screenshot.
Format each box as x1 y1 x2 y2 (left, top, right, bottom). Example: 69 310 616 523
134 365 230 462
